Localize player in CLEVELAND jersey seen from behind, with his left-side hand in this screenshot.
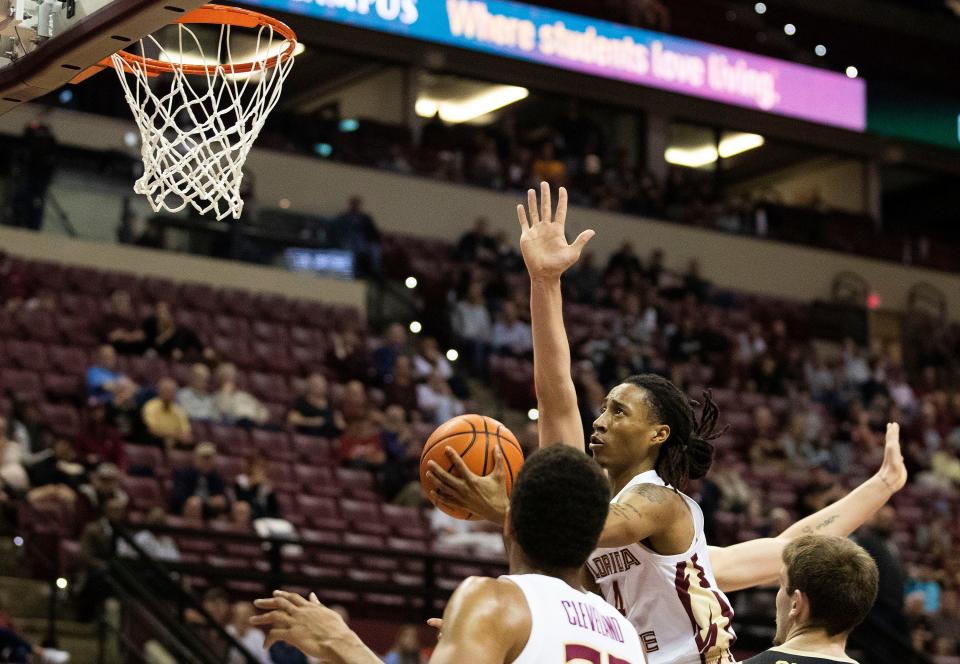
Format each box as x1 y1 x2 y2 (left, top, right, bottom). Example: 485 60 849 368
250 446 644 664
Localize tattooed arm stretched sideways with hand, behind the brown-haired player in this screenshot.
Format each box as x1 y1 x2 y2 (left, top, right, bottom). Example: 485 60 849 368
710 423 907 592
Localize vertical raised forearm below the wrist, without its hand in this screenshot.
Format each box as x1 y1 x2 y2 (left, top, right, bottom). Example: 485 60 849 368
530 277 583 446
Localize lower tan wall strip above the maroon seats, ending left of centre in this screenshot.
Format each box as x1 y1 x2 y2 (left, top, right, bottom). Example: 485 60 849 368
0 228 366 311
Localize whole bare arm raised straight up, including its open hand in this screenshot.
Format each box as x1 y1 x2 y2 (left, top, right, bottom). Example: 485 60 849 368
517 182 594 449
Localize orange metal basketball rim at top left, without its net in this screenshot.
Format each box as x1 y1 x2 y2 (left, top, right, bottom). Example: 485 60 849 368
99 5 297 76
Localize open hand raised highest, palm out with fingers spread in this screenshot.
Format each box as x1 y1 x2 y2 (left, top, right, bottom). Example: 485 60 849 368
517 182 595 280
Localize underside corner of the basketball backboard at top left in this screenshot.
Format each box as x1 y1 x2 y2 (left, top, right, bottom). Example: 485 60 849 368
0 0 205 114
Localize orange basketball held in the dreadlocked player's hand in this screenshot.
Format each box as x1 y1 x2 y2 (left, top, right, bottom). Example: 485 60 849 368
420 415 523 519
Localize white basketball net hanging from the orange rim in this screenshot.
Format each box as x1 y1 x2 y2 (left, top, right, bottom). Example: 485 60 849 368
113 24 293 219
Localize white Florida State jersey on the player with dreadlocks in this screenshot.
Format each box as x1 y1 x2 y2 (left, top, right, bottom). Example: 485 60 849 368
587 470 737 664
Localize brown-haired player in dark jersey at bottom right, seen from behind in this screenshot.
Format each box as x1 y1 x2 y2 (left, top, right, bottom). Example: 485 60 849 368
744 535 879 664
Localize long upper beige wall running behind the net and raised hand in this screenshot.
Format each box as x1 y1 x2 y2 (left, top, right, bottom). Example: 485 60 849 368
0 107 960 319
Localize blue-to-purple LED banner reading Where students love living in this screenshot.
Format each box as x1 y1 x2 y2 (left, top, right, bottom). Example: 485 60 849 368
243 0 866 131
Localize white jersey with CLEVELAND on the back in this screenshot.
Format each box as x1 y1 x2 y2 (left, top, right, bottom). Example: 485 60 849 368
500 574 644 664
